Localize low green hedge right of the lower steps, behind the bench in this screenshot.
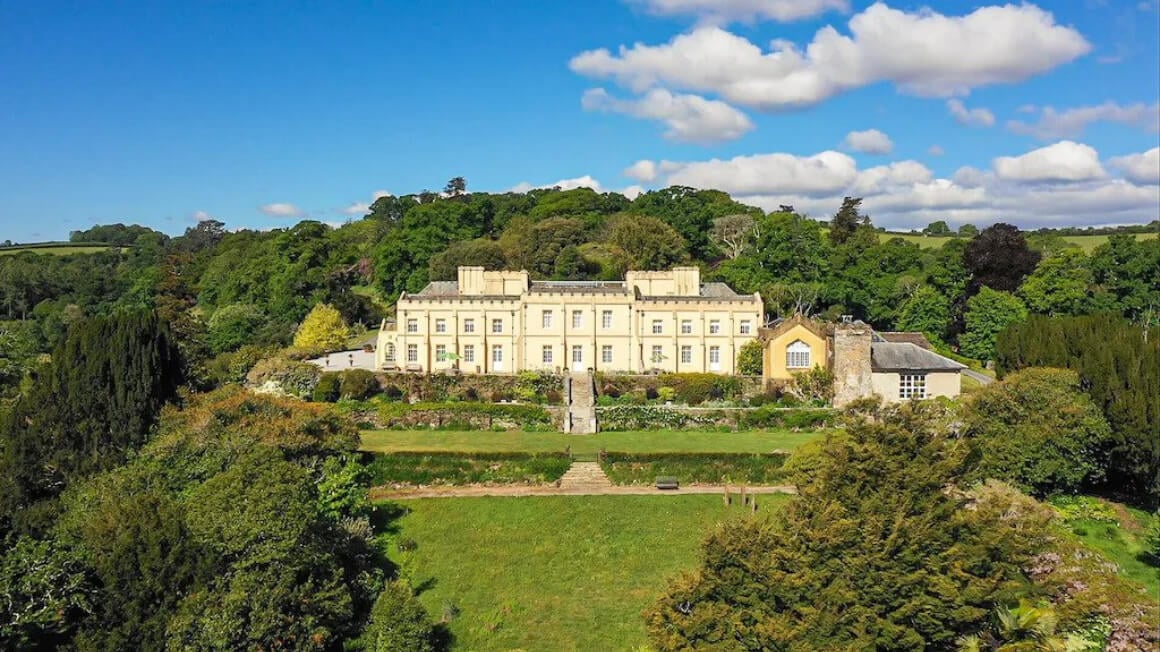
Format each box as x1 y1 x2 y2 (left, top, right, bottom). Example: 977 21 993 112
601 452 789 485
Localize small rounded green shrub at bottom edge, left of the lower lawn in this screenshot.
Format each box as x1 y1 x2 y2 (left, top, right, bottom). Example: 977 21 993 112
363 580 436 652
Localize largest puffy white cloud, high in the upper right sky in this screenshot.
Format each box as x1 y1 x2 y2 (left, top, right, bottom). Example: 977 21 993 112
570 2 1092 111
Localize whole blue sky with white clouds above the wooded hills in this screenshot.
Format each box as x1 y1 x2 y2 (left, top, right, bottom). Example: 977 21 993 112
0 0 1160 241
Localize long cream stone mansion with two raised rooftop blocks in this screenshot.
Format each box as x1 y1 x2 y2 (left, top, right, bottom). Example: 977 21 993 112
376 267 763 374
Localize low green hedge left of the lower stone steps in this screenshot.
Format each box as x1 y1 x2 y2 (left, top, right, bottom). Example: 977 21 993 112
368 452 572 486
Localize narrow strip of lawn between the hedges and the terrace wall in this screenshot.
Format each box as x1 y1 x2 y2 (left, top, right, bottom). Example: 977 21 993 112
362 430 825 454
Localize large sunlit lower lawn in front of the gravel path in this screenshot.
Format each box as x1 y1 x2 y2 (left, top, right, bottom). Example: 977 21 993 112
386 495 788 651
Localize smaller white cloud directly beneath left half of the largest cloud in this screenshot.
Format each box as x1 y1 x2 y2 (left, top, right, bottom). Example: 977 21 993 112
580 88 753 144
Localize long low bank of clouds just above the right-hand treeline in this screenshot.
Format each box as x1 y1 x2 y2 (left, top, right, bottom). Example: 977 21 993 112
635 142 1160 229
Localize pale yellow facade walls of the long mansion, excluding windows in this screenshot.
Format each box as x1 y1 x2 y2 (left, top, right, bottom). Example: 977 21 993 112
377 273 762 374
